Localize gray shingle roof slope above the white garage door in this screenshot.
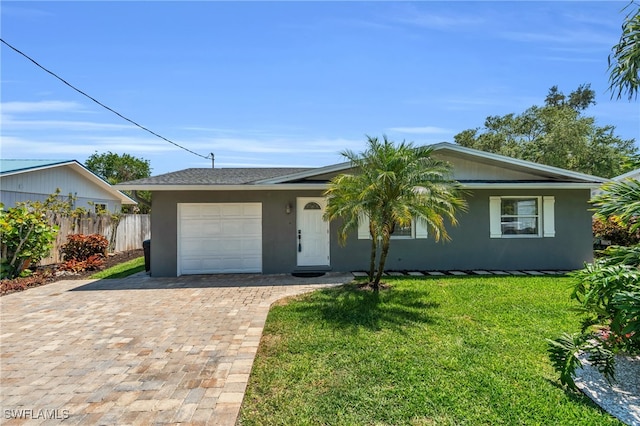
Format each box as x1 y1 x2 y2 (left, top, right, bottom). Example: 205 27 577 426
122 167 311 185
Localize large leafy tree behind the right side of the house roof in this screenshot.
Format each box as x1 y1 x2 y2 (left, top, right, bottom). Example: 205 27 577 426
454 84 638 178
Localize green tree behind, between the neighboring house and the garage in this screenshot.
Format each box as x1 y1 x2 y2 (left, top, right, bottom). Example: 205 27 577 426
84 151 151 213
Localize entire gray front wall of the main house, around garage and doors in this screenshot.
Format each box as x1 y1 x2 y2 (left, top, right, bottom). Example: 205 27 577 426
151 189 593 276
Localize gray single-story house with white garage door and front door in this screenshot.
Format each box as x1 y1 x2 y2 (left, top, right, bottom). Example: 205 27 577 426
117 143 605 276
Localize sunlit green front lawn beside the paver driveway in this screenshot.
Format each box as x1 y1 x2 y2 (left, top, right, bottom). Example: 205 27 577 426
239 277 621 425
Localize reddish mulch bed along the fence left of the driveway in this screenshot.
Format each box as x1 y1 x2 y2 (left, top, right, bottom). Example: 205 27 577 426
0 249 144 296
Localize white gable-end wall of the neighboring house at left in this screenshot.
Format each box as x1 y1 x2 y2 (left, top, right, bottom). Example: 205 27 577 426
0 167 121 212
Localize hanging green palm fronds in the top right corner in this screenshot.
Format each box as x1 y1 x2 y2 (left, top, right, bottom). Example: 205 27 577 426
609 1 640 100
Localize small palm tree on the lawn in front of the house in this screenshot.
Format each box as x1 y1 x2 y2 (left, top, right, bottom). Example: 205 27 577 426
325 136 466 291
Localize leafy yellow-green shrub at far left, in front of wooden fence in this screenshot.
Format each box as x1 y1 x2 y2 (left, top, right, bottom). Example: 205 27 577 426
0 203 58 279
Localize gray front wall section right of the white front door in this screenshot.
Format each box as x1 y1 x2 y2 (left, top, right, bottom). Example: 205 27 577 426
332 189 593 270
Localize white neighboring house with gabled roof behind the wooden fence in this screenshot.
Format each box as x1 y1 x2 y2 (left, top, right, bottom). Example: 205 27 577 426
0 159 137 212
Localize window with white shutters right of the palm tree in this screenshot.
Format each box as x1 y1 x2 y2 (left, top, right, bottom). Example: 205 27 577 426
489 196 555 238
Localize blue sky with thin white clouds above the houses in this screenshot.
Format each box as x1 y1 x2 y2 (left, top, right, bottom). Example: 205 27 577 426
0 1 640 175
